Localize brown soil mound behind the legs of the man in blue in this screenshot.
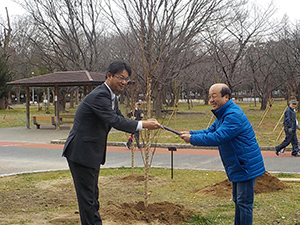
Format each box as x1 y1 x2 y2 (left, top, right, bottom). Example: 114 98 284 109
196 172 289 197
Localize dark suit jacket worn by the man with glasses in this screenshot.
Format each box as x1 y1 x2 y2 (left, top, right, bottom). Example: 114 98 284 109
63 84 138 169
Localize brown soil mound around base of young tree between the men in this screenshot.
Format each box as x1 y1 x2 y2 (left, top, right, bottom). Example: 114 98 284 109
101 201 194 225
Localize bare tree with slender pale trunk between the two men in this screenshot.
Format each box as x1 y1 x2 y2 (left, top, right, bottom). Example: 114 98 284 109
105 0 225 206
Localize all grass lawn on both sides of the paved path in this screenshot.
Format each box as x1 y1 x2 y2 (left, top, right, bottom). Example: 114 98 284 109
0 101 300 225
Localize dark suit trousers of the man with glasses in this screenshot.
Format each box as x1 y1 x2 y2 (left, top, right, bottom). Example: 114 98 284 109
68 160 102 225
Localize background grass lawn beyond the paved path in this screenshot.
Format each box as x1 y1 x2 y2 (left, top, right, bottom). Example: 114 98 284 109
0 100 290 146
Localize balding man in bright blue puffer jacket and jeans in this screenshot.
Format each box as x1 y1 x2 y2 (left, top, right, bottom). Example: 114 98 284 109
180 83 265 225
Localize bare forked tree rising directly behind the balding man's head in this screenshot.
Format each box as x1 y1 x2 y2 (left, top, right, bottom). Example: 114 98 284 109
208 3 275 91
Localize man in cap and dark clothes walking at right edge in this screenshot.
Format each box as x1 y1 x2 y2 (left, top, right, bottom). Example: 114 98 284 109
275 100 300 157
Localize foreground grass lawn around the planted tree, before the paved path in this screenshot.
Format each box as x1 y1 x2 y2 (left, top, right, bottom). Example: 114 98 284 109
0 168 300 225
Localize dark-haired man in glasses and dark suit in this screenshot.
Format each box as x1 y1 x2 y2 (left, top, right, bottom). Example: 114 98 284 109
63 61 162 225
